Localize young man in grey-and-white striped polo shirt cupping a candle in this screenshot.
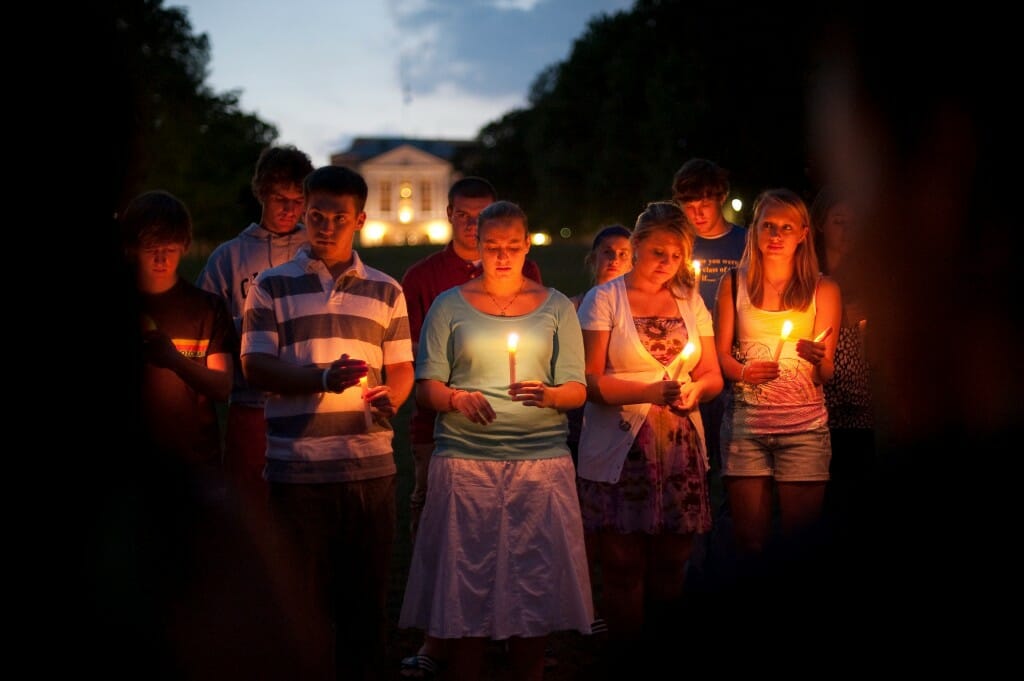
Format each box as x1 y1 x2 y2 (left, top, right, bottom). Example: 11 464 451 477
241 166 413 679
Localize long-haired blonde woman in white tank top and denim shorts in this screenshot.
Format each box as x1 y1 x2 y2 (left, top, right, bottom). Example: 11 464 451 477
715 188 842 555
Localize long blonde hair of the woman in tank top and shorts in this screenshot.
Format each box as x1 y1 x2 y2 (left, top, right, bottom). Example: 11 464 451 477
739 187 820 309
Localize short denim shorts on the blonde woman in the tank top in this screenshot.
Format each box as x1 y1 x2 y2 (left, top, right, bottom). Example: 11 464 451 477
722 426 831 482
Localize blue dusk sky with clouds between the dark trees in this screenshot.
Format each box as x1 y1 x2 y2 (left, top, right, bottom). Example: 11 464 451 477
174 0 633 165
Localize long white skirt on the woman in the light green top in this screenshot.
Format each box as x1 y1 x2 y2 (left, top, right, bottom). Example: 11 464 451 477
398 456 594 640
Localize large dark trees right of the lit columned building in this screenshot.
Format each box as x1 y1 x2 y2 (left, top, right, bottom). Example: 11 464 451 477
467 0 835 231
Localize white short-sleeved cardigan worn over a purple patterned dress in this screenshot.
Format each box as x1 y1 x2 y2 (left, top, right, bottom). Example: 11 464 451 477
578 276 715 482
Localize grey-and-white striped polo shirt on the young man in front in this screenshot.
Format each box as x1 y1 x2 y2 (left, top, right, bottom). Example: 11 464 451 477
241 245 413 483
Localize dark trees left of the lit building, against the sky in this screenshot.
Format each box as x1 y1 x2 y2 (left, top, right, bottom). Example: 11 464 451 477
110 0 278 241
